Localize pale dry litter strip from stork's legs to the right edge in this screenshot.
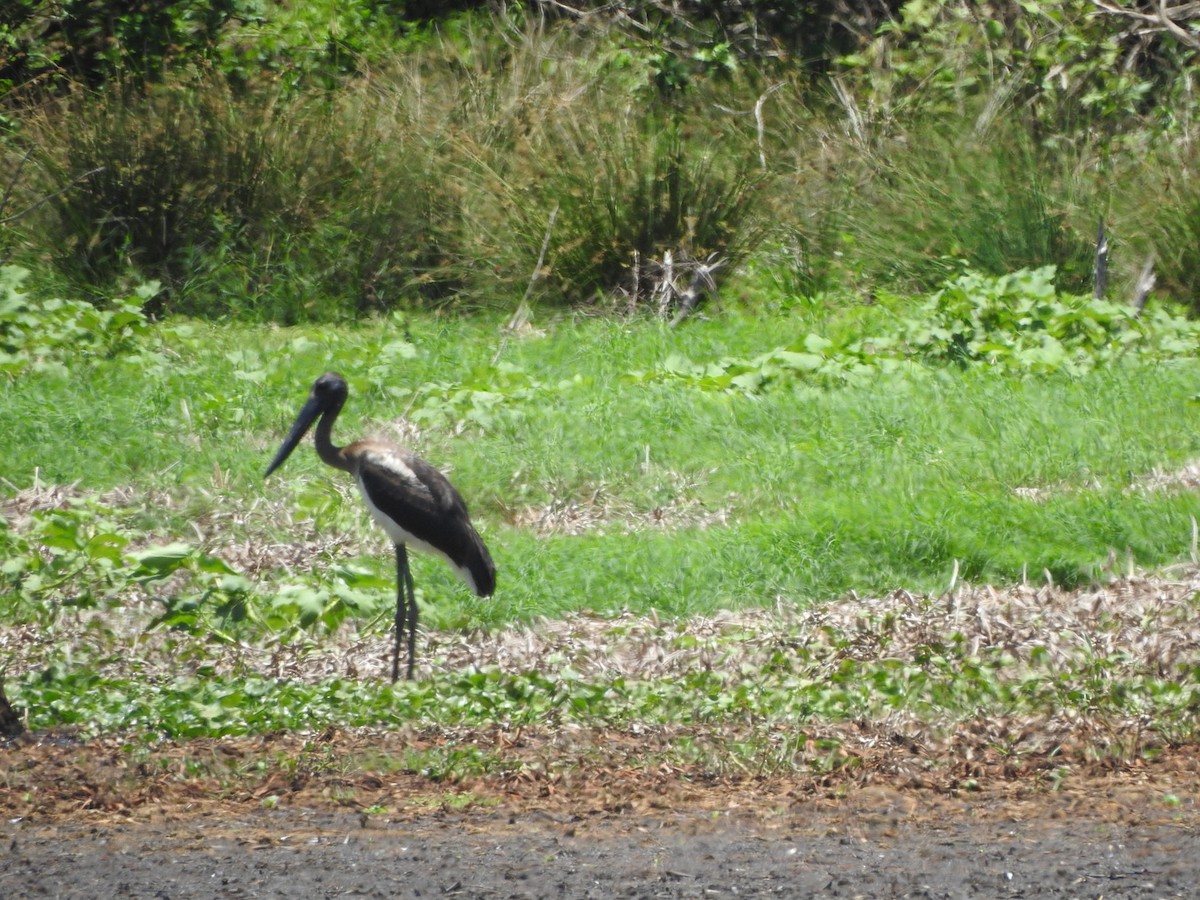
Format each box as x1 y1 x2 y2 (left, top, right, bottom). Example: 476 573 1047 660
428 566 1200 678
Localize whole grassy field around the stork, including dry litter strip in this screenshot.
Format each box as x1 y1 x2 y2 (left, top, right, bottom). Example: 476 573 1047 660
0 278 1200 770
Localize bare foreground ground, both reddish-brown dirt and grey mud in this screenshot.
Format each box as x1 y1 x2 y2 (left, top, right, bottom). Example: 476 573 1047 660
0 732 1200 899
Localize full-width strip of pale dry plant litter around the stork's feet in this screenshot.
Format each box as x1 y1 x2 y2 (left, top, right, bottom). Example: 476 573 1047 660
7 565 1200 682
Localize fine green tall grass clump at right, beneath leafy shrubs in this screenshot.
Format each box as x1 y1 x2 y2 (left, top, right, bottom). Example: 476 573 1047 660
830 108 1104 290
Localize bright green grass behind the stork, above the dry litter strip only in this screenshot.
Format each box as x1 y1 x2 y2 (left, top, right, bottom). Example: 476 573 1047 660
0 309 1200 626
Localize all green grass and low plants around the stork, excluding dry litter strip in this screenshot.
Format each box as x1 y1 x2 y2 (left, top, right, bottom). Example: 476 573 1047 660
0 292 1200 748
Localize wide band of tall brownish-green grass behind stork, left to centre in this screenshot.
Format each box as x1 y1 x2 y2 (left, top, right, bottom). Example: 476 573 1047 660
14 18 782 320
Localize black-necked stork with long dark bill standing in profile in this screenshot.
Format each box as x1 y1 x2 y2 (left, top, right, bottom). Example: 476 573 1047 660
263 372 496 682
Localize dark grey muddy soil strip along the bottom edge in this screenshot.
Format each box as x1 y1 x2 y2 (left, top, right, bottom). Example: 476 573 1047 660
0 810 1200 899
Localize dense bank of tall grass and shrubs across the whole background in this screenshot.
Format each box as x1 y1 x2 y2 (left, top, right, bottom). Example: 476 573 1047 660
0 0 1200 322
